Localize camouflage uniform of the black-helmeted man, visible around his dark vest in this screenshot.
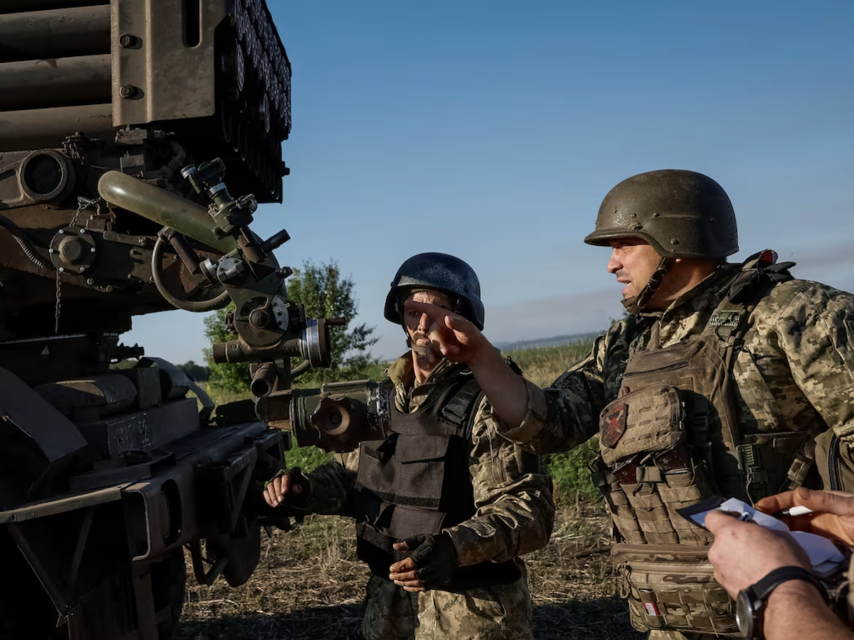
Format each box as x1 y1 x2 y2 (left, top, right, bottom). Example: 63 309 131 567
306 354 554 640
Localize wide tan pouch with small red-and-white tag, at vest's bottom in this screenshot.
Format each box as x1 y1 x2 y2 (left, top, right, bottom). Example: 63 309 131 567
611 544 741 637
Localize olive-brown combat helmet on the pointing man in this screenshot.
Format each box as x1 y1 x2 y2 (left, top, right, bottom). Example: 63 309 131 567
584 169 738 259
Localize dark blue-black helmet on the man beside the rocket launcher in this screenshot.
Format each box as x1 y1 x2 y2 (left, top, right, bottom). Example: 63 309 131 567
384 253 484 330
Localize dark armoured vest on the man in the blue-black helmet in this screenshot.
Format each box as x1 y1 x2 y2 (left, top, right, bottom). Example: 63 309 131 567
356 377 521 591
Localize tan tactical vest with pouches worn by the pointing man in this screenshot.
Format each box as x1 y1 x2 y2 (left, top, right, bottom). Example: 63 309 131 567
594 252 809 636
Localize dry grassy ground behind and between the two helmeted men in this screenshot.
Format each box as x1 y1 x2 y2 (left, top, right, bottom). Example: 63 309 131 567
178 343 642 640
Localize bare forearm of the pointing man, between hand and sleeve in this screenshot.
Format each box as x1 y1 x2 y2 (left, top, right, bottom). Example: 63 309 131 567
469 348 528 430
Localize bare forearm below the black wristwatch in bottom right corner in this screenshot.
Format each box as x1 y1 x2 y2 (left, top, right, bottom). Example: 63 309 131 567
764 580 854 640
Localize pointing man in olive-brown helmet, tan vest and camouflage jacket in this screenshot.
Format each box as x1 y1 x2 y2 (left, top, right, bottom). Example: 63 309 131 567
404 170 854 638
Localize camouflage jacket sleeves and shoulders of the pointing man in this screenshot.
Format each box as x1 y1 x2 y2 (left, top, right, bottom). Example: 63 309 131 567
504 264 854 454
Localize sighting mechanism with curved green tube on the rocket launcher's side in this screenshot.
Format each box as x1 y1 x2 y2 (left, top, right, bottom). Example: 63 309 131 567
98 158 331 388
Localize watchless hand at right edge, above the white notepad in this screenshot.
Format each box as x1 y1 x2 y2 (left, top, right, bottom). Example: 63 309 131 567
756 487 854 547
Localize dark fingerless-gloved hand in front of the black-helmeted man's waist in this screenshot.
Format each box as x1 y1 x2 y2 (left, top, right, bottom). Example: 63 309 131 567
389 533 459 592
